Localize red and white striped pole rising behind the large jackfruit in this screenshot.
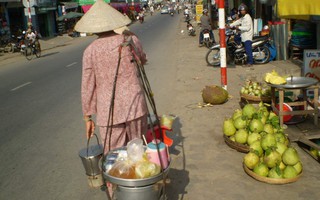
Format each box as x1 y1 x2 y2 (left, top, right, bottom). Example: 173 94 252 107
218 0 227 90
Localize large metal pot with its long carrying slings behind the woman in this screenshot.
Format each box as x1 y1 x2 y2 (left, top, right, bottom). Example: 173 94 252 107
102 33 170 200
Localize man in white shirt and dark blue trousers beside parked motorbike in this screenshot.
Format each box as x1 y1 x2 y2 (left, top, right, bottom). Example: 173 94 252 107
229 4 253 67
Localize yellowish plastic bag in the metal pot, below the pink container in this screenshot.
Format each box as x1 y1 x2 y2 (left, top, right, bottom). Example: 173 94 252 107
135 160 160 179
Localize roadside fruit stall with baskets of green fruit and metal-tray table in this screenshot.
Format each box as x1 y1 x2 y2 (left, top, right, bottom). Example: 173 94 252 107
222 71 320 184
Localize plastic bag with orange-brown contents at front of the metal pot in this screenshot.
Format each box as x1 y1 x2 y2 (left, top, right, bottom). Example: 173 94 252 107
109 160 136 179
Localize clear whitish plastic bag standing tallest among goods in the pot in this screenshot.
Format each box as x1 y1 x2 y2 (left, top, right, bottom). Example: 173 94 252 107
127 138 145 163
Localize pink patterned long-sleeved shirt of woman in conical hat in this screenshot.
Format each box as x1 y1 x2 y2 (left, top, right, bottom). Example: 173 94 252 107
81 33 147 126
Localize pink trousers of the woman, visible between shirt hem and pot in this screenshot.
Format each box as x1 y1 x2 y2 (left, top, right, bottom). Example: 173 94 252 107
99 114 148 155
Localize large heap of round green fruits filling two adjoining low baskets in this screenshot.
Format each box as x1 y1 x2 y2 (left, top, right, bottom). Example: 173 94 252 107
223 102 302 179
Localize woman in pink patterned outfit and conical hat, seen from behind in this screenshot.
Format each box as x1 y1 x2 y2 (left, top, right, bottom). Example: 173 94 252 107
75 0 147 169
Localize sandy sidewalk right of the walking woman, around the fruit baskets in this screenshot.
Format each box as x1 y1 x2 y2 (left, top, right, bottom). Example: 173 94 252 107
168 16 320 200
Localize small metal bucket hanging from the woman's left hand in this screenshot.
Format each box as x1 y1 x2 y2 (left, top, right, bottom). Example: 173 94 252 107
79 134 103 176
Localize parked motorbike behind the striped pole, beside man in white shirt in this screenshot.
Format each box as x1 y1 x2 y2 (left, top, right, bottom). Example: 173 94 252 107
206 29 271 66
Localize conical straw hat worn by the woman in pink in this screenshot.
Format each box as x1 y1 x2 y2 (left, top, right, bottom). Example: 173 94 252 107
74 0 131 33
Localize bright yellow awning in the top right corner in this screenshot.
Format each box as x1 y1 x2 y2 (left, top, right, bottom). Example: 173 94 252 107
277 0 320 19
